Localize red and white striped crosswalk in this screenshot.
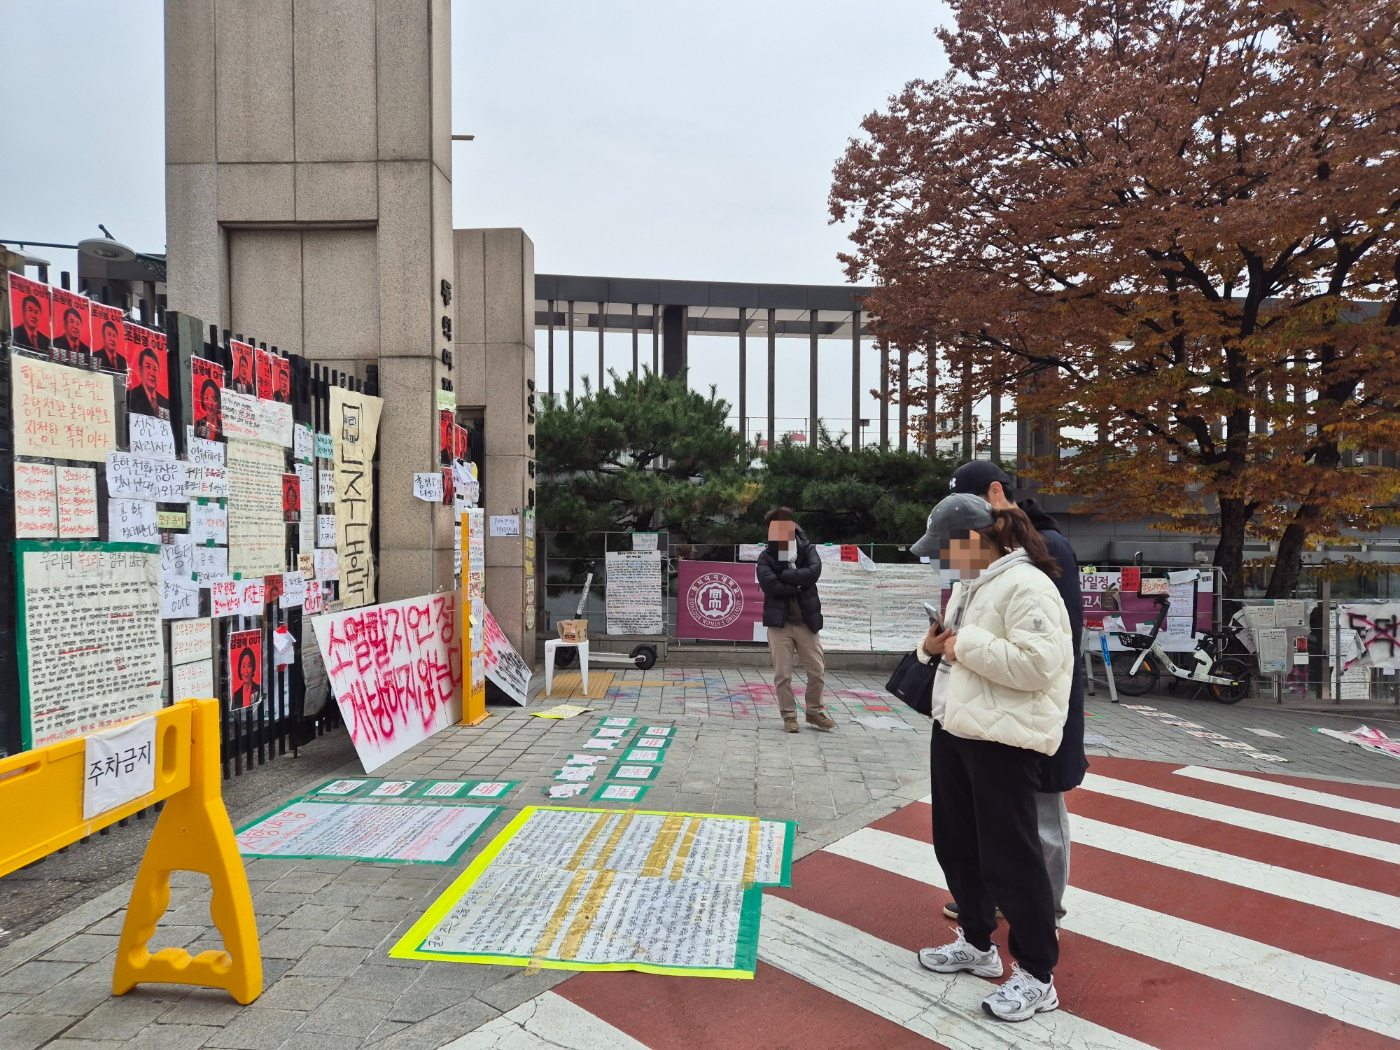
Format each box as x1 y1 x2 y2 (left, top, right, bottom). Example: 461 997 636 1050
444 759 1400 1050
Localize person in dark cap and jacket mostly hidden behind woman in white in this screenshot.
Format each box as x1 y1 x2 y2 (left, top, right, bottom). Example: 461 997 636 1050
944 459 1089 924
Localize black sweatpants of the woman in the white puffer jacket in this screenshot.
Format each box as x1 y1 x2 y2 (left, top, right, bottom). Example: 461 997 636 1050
931 722 1060 980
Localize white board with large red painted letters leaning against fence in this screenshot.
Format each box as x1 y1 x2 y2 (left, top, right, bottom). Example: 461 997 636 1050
311 596 462 773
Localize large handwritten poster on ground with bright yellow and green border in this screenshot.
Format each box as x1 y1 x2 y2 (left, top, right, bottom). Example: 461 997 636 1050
389 806 795 977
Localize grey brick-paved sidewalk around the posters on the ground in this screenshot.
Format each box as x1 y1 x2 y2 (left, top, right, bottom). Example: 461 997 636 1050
0 666 1400 1050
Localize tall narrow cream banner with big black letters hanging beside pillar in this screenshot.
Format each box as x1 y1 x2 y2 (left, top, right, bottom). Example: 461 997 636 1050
330 386 384 609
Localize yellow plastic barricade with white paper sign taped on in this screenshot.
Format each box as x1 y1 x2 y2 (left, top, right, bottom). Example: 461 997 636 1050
0 700 262 1005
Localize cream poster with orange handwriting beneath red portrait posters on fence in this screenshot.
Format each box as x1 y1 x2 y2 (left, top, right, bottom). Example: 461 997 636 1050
10 354 116 463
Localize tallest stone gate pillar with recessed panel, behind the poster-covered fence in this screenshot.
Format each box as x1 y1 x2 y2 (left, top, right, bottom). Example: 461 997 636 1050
165 0 461 601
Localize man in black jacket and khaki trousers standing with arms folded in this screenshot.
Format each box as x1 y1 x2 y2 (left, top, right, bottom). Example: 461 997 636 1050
757 507 836 732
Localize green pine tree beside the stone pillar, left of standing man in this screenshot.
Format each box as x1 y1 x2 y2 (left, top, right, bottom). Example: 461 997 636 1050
535 371 759 539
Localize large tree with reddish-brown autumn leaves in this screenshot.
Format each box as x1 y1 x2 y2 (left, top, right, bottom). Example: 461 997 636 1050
832 0 1400 596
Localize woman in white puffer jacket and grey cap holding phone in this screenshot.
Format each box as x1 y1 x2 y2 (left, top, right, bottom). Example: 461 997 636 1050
910 493 1074 1021
